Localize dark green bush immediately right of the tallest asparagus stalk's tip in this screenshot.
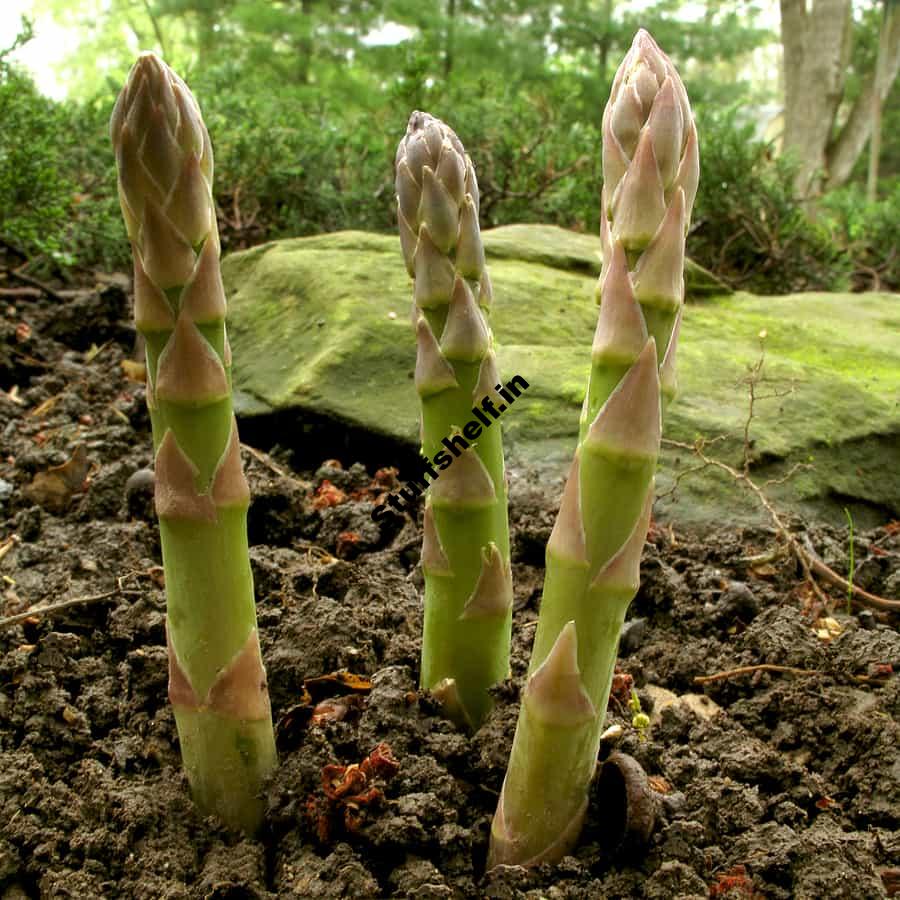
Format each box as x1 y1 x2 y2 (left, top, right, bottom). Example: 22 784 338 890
688 109 849 294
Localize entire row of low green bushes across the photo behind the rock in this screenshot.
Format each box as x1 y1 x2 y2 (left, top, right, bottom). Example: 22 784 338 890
0 42 888 293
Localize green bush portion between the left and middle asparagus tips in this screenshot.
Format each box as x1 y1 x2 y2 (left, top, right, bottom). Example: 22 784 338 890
191 65 394 249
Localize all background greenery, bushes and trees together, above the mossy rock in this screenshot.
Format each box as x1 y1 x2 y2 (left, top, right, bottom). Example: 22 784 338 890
12 0 900 292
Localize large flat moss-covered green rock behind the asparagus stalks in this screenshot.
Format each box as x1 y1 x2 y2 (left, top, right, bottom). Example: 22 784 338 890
223 225 900 523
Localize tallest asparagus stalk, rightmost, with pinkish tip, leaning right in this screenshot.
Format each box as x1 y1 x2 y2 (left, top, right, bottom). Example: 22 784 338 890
488 30 699 866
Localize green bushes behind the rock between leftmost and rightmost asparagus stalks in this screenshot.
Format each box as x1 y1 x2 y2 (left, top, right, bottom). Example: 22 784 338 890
191 60 600 249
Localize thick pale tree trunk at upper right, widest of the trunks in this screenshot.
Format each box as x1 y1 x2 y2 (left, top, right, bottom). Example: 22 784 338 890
781 0 853 197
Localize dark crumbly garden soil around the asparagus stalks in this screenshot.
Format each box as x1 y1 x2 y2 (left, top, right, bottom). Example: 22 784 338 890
0 282 900 900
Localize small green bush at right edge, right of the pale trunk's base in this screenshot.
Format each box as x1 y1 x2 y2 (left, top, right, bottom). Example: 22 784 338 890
821 179 900 291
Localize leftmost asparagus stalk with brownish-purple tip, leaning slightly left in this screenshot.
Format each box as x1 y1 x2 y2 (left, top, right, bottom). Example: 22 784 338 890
110 53 276 832
